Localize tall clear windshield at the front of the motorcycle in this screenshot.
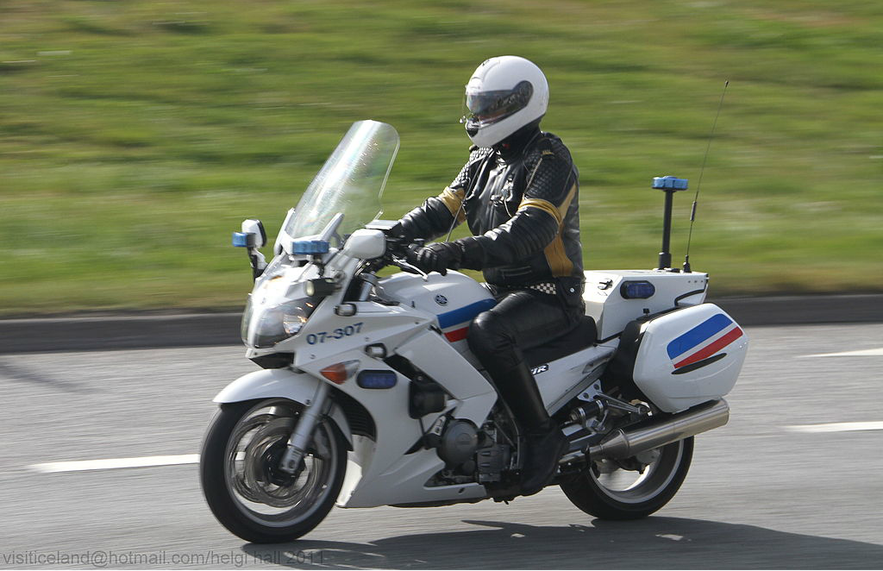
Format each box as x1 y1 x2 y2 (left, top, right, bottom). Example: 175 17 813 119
282 121 399 239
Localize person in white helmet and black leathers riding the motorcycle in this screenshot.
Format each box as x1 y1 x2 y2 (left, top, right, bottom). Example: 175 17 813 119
401 56 584 495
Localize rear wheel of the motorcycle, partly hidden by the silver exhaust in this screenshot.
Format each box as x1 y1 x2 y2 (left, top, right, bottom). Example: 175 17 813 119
561 436 693 520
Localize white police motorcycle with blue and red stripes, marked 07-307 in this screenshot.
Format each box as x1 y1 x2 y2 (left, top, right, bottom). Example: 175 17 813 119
200 121 748 543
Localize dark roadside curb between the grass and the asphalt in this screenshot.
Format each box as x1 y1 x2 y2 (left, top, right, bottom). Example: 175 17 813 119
0 294 883 354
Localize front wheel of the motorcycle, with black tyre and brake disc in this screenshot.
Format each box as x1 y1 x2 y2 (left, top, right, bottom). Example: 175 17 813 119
199 400 346 543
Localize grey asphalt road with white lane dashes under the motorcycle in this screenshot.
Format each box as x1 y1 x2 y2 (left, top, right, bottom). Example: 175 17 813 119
0 324 883 569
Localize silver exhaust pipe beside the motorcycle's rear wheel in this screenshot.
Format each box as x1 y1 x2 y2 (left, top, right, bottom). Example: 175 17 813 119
588 399 730 458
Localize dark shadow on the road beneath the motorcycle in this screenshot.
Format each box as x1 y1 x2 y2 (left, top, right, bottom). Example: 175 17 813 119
243 517 883 570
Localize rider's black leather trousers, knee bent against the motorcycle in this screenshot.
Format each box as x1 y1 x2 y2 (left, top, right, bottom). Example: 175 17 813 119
468 289 583 431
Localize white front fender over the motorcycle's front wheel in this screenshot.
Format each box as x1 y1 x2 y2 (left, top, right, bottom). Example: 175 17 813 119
214 369 353 448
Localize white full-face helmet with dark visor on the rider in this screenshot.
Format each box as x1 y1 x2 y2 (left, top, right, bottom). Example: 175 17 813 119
460 56 549 147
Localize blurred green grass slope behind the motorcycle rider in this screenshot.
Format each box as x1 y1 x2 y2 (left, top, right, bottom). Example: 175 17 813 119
0 0 883 316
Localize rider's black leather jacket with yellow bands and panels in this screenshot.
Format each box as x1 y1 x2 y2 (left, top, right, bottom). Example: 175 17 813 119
402 125 584 297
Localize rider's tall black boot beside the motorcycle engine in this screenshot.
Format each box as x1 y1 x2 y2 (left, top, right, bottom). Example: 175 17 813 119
489 361 569 496
